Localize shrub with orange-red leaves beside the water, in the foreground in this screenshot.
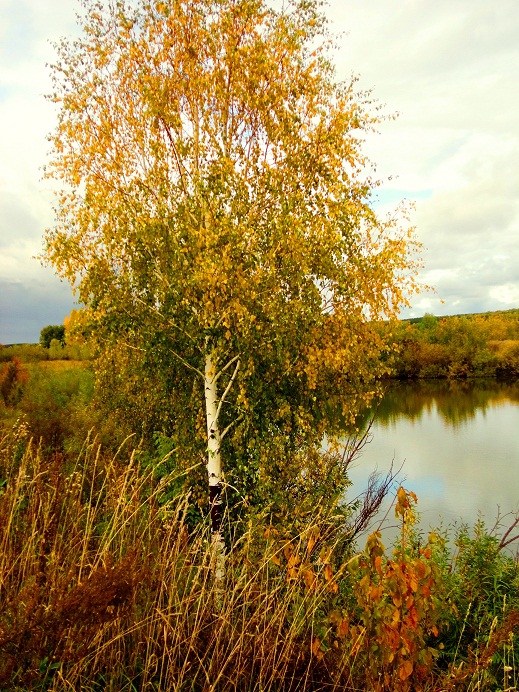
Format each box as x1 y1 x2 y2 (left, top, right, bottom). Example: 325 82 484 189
334 487 446 691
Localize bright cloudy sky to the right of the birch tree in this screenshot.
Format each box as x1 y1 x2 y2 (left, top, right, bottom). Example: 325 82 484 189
332 0 519 314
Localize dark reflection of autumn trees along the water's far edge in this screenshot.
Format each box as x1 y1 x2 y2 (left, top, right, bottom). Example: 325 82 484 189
375 379 519 426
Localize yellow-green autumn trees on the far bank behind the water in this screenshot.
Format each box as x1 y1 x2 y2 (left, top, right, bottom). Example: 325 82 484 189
393 309 519 379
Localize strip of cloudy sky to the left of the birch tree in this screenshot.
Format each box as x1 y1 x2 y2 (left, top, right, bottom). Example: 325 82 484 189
0 0 79 343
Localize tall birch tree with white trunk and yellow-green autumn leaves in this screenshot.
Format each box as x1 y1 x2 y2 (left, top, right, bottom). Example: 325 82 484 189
45 0 422 540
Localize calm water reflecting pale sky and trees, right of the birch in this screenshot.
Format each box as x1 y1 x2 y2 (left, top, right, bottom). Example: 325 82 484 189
350 380 519 544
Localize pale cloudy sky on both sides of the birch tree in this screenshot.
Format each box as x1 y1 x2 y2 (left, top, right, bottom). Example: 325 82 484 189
0 0 519 344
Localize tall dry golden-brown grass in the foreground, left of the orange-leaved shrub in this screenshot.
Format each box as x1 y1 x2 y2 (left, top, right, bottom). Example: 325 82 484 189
0 426 360 692
